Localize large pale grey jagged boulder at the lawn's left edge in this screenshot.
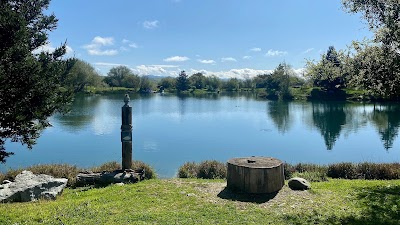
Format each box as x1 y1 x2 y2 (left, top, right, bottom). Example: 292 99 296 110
0 170 68 202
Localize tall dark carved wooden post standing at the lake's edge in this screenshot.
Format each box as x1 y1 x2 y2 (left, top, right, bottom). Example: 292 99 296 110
121 94 132 170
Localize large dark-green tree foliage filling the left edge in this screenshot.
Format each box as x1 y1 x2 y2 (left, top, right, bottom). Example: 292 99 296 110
0 0 75 162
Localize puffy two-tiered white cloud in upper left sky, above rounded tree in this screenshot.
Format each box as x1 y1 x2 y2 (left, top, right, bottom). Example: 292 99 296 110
83 36 118 56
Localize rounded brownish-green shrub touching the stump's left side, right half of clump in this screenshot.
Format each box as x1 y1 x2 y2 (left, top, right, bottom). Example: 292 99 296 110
197 160 227 179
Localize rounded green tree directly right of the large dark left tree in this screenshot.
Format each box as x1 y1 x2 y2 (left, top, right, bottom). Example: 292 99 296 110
66 59 102 92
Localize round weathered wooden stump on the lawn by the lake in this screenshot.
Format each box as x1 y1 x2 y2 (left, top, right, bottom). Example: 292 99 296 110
227 157 285 194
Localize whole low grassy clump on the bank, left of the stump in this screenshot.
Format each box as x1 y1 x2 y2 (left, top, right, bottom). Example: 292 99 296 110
178 160 227 179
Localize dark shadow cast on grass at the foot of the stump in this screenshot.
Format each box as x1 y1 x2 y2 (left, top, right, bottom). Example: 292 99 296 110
217 187 278 204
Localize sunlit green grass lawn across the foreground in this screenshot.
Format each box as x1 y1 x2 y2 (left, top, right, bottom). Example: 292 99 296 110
0 179 400 225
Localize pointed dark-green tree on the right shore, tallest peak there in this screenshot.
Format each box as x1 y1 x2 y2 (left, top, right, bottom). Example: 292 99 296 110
306 46 346 91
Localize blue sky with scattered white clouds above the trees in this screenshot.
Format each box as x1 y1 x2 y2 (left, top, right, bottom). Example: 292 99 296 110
40 0 372 78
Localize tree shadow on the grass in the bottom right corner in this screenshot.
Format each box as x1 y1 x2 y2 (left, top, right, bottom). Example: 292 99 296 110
285 186 400 225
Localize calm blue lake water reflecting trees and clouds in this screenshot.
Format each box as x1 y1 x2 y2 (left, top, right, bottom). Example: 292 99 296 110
0 94 400 177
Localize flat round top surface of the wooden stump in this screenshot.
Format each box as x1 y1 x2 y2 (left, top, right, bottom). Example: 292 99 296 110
228 156 283 168
